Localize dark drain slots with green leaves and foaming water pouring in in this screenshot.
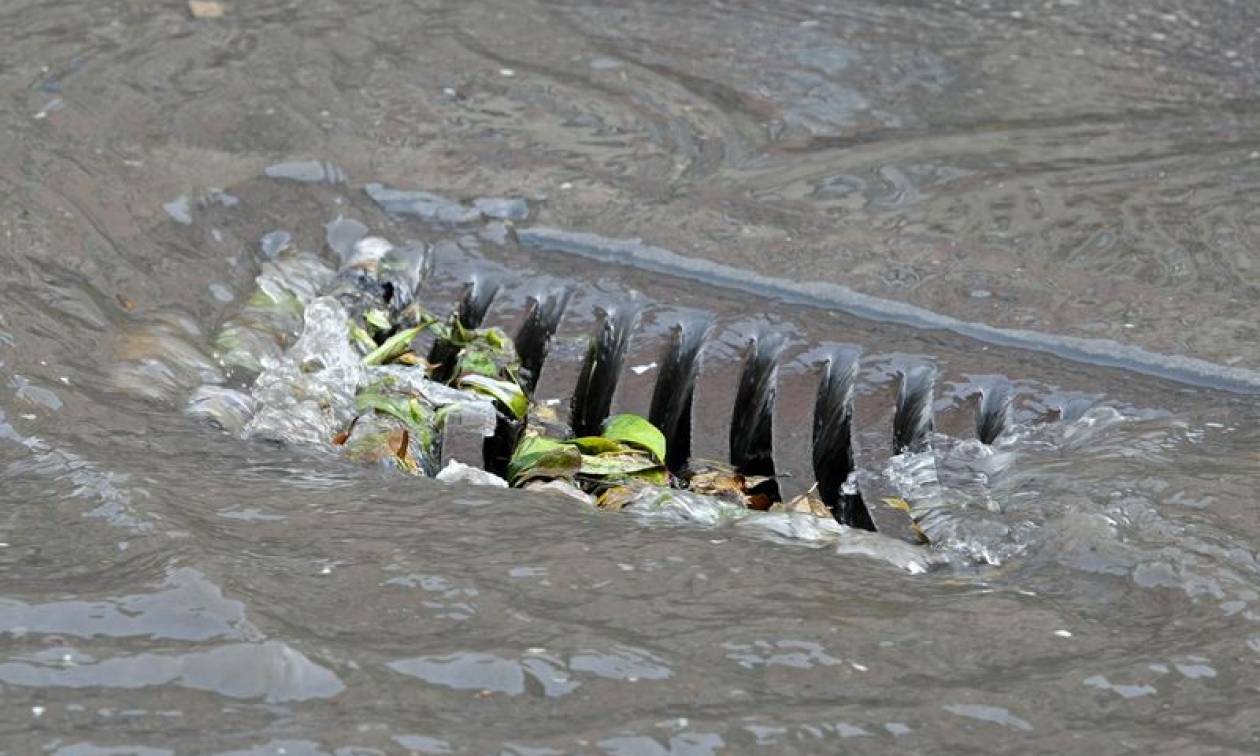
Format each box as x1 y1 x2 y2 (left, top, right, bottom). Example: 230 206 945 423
180 219 1103 549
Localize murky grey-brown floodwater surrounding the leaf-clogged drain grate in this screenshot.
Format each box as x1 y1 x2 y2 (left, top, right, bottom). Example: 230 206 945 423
0 0 1260 753
